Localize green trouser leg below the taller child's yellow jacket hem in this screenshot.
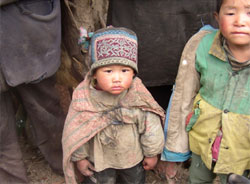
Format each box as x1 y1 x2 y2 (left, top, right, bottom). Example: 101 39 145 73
188 153 216 184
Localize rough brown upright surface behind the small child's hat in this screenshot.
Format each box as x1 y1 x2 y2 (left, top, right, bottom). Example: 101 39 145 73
56 0 108 113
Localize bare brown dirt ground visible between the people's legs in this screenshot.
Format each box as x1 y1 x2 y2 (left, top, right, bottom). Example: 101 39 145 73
19 136 188 184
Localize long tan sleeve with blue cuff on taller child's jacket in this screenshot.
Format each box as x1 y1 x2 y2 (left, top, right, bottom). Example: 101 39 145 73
161 30 213 162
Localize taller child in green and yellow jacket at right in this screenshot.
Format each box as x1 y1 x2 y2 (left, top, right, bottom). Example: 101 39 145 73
162 0 250 183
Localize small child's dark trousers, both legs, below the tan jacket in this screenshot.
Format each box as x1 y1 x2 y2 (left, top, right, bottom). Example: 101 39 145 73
82 163 145 184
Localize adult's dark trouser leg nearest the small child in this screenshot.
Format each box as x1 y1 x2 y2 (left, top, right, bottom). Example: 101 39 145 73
16 77 66 174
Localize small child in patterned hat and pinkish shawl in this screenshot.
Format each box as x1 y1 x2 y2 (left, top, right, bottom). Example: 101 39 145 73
62 27 164 184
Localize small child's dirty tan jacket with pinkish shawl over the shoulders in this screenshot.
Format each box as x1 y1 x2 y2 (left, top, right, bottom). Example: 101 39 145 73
62 75 165 183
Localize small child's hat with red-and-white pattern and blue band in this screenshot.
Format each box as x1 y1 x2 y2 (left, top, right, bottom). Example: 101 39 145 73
90 27 138 73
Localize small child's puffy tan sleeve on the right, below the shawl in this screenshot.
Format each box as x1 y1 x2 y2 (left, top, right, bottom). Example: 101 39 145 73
139 112 164 157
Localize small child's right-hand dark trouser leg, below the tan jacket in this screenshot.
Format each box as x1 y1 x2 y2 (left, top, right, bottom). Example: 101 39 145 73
117 163 145 184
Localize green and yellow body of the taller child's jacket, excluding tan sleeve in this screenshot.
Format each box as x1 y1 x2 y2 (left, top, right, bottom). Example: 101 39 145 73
189 32 250 174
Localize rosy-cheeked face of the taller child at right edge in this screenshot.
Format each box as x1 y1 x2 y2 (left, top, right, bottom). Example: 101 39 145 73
215 0 250 48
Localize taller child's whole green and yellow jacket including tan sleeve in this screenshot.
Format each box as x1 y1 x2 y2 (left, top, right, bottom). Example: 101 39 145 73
163 27 250 175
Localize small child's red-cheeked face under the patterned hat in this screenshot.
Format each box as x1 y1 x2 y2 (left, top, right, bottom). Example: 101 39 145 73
94 65 134 95
